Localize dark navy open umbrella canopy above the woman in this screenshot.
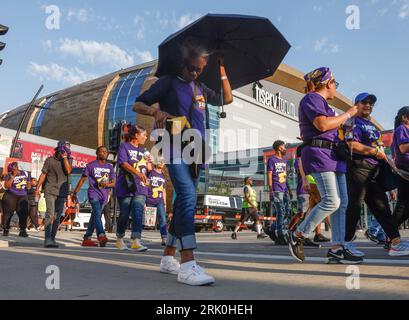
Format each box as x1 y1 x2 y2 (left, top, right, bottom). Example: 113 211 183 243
156 14 291 91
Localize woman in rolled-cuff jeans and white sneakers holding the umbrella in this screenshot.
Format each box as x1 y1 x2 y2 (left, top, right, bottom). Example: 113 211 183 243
134 39 233 286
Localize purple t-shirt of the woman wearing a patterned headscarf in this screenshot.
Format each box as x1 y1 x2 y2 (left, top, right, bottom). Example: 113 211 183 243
299 92 346 175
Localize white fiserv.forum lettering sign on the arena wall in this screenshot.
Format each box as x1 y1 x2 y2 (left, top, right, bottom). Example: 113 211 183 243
253 84 296 117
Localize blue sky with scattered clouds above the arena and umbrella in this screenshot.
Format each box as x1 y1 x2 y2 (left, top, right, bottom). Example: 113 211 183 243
0 0 409 128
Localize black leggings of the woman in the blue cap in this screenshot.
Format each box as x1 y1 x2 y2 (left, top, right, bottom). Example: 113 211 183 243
345 160 400 242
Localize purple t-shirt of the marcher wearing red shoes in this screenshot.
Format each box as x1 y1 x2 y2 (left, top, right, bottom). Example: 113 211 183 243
83 160 115 204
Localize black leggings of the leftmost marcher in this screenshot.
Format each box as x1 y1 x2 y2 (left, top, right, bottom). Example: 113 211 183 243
2 192 28 230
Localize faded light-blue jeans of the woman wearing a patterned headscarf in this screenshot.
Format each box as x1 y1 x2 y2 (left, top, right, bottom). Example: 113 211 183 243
297 172 348 245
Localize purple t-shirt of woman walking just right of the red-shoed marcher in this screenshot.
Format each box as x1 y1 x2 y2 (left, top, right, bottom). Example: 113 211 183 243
116 142 149 198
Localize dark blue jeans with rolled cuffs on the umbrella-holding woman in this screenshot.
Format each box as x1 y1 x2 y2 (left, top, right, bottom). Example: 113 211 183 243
166 160 199 251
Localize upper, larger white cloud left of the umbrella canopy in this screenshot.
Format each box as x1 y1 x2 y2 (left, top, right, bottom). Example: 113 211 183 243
57 39 135 68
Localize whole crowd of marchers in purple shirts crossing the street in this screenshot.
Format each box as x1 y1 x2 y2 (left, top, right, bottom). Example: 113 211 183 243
2 38 409 285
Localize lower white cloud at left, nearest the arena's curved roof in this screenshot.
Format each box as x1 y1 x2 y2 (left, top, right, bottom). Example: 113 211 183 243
29 62 97 85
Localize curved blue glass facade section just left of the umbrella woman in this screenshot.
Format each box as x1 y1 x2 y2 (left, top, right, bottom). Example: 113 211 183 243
104 66 153 150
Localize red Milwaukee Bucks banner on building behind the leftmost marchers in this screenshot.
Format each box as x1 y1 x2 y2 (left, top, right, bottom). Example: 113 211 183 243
14 140 96 169
